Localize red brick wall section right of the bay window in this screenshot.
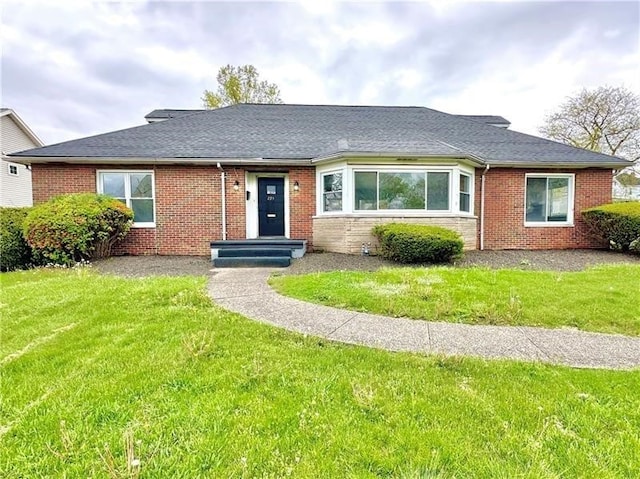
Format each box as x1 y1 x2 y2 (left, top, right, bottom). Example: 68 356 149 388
475 168 612 249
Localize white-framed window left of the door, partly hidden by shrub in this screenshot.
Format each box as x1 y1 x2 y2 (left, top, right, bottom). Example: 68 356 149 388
98 171 155 226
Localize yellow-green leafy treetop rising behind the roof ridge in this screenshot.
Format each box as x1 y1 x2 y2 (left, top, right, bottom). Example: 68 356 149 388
202 65 282 109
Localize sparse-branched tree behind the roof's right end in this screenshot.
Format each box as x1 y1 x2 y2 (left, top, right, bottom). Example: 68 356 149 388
540 86 640 161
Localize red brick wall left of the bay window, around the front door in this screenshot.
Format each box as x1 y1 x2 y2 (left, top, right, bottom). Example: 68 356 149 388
32 164 315 255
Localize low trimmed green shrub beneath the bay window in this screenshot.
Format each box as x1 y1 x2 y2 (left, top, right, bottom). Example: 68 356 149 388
372 223 463 263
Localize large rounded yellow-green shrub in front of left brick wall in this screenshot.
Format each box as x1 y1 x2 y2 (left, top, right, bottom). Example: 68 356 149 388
24 193 133 264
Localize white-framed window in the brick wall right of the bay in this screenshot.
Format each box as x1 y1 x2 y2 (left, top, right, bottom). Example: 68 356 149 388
525 175 573 225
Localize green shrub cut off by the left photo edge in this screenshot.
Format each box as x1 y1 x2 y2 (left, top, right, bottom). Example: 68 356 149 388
0 208 33 271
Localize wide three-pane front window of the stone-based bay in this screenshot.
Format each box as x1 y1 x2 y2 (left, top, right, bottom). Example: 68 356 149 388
354 171 449 211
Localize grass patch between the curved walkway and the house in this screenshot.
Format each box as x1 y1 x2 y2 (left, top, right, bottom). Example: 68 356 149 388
270 265 640 335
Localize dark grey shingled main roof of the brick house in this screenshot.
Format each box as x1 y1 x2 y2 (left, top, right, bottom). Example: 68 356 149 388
10 104 629 167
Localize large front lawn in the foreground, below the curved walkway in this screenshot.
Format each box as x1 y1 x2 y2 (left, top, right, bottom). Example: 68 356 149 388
0 269 640 478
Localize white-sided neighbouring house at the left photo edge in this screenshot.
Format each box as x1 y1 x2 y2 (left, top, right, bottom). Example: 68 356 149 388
0 108 44 206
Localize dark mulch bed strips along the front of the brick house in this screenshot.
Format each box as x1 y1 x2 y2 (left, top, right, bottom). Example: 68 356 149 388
93 250 640 277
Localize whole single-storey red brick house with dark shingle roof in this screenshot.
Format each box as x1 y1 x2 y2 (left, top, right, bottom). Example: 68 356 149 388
7 104 629 255
